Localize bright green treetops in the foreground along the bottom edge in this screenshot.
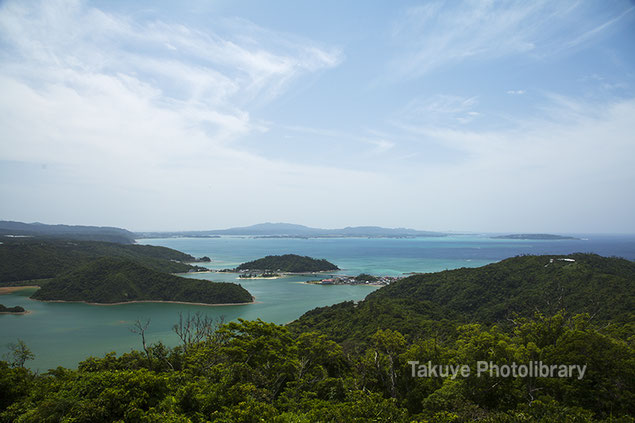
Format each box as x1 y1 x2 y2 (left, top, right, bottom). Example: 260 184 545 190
0 313 635 422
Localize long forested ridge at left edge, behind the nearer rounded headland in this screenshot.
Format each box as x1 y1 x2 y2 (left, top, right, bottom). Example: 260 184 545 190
0 238 205 283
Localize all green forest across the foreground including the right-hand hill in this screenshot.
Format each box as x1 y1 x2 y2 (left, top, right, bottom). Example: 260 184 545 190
0 254 635 423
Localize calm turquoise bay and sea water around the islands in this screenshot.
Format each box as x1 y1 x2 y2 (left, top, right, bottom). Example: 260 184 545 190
0 235 635 370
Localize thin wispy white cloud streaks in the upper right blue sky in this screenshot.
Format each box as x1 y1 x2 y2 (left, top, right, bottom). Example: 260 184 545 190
389 0 632 78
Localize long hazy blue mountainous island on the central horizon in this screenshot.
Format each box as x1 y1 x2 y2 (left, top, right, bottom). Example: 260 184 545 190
136 222 447 238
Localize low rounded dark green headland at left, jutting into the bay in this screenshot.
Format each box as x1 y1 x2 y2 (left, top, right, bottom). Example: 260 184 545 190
32 257 253 304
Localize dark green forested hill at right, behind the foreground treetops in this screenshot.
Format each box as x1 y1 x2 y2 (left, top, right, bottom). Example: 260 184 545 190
292 254 635 341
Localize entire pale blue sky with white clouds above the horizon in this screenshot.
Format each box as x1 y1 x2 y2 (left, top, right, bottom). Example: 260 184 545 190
0 0 635 233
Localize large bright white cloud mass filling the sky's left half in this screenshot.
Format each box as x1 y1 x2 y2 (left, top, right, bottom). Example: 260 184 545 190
0 1 381 229
